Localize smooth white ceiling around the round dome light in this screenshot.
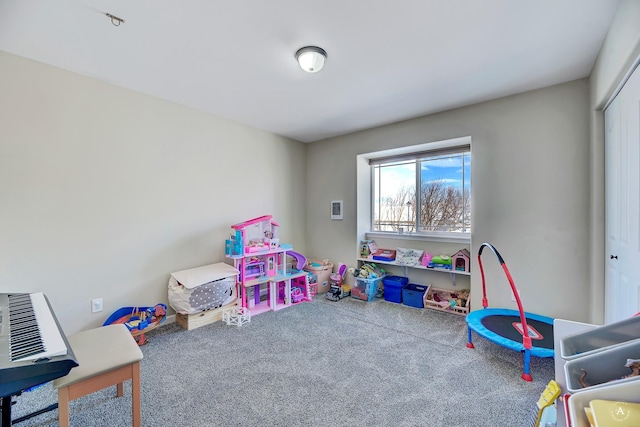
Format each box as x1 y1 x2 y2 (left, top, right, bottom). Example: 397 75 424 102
0 0 619 142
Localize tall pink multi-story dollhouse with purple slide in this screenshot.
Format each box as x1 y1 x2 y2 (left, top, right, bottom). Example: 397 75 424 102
225 215 311 315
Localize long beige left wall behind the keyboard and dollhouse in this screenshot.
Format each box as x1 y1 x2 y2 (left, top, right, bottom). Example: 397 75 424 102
0 52 306 334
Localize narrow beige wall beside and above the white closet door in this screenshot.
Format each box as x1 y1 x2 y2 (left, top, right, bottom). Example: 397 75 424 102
588 0 640 324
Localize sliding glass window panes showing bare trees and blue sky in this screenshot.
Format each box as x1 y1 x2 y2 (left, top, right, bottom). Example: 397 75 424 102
369 145 471 235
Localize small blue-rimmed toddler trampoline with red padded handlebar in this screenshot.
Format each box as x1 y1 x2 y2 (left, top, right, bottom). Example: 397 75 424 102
467 243 554 381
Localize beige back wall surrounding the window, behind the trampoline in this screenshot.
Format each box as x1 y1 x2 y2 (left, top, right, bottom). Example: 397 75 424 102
307 79 589 321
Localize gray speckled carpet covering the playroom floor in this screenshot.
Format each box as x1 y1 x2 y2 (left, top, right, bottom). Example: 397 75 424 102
8 296 554 427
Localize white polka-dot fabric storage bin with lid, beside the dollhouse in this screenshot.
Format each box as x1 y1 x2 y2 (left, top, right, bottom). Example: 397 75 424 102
169 262 239 329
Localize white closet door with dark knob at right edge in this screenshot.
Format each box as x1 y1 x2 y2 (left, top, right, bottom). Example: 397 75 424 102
605 65 640 323
